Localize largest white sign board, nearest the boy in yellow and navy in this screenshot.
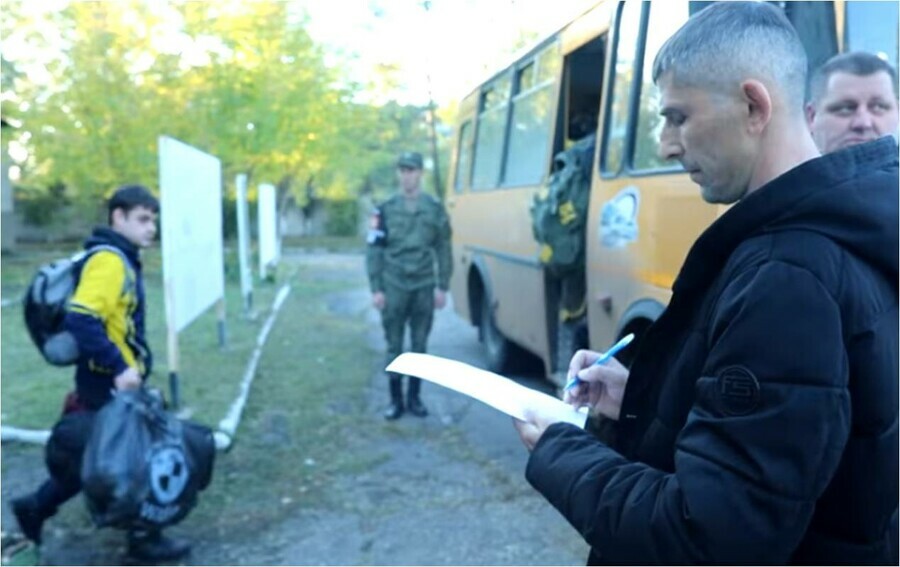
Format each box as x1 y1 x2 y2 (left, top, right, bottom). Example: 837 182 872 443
159 136 225 333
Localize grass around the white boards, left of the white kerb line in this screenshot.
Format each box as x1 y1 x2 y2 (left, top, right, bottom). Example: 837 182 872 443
0 242 287 428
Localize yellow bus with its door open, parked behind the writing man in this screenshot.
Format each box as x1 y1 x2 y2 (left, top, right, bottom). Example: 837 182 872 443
445 0 898 383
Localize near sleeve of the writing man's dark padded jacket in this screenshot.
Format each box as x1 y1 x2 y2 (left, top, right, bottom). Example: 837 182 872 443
526 262 850 564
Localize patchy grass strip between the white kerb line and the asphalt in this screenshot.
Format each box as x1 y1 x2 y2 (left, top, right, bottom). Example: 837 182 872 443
193 271 375 532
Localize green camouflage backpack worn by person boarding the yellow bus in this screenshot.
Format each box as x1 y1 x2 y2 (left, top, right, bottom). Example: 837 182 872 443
531 135 596 277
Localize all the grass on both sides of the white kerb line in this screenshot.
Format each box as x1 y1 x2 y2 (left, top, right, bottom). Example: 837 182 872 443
0 244 383 552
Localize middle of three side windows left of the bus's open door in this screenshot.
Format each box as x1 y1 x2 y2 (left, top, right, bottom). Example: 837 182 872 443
472 73 510 190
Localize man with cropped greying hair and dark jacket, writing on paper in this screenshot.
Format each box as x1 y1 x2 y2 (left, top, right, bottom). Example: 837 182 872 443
515 2 900 565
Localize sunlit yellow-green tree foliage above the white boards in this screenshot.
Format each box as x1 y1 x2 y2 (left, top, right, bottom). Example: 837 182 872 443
0 0 458 217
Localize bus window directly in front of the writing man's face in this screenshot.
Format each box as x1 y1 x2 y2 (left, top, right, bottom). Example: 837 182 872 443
634 2 688 170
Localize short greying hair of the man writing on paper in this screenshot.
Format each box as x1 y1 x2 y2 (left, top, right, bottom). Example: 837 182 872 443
653 2 807 112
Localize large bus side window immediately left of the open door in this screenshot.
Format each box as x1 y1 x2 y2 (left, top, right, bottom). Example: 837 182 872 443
503 43 559 186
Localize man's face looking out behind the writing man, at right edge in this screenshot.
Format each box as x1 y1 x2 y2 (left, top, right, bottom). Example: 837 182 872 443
806 51 900 154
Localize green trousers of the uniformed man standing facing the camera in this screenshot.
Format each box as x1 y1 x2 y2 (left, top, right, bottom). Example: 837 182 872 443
381 285 434 376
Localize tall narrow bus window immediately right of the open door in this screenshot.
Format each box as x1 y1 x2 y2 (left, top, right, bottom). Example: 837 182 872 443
601 0 642 174
